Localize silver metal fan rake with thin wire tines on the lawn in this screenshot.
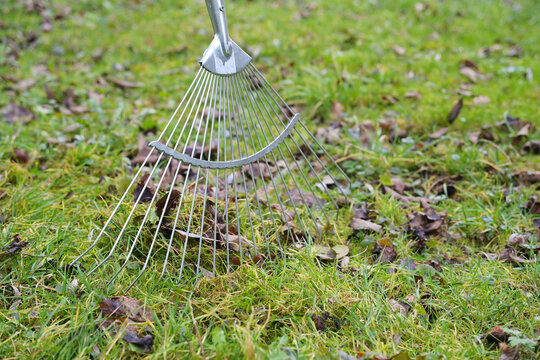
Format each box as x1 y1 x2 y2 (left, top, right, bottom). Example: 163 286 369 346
72 0 350 291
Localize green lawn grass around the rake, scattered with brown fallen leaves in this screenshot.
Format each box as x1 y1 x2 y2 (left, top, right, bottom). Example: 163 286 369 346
0 0 540 359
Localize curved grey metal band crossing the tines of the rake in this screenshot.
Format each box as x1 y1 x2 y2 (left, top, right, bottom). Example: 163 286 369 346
148 114 300 169
